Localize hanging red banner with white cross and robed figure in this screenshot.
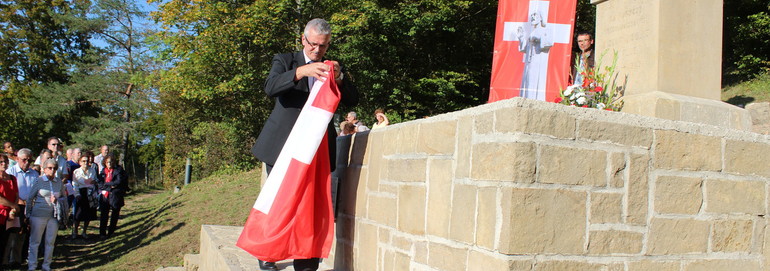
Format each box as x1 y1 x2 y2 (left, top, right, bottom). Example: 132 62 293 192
488 0 577 103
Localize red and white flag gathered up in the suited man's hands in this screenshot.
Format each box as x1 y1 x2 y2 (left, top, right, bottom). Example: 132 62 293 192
236 61 340 262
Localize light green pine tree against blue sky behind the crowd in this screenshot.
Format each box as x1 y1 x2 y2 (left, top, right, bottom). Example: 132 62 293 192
16 0 156 169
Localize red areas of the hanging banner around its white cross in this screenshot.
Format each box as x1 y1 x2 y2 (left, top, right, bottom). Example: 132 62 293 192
488 0 577 103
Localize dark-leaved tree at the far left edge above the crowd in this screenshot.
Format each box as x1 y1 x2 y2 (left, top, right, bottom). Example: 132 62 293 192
0 0 94 148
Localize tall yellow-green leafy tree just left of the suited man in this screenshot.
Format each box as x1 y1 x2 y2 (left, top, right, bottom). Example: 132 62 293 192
153 0 299 183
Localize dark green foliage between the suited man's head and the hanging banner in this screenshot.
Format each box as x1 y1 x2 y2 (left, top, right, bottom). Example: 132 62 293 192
329 0 497 123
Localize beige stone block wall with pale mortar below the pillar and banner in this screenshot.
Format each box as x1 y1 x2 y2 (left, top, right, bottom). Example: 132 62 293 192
326 98 770 271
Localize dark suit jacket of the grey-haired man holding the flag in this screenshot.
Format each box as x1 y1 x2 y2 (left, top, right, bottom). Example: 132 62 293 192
251 51 358 171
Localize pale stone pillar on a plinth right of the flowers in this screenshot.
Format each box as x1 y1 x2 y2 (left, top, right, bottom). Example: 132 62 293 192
591 0 751 130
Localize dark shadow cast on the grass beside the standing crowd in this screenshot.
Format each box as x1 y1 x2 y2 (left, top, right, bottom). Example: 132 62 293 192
51 192 185 270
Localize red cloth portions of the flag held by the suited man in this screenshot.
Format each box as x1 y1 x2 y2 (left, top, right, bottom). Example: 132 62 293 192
236 61 340 262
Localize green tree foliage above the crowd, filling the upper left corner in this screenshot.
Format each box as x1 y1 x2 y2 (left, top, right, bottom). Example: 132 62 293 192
0 0 163 188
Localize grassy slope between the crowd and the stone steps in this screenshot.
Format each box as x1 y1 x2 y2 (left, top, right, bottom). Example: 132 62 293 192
48 170 259 270
